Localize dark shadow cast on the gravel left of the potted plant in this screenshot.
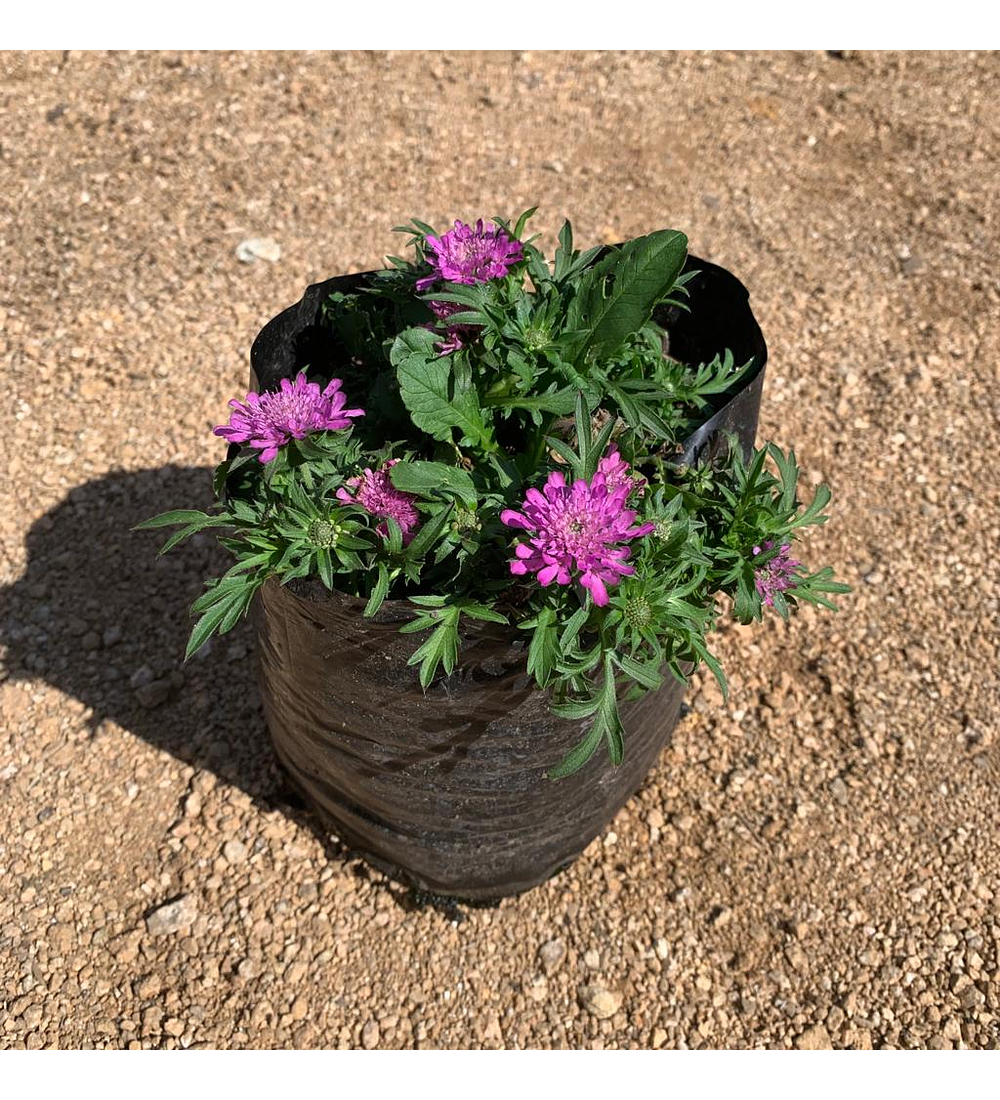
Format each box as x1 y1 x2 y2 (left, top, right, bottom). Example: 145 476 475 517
0 465 473 916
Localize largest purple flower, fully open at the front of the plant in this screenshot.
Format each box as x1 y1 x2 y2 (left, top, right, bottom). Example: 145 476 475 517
501 470 653 607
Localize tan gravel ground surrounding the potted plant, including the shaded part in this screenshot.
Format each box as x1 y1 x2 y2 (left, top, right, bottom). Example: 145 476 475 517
0 51 1000 1049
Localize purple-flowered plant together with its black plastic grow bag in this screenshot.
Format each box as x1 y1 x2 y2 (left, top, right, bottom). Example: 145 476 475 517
141 211 847 900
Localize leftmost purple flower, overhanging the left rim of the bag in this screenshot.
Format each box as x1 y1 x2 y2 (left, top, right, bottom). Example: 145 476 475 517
215 374 364 462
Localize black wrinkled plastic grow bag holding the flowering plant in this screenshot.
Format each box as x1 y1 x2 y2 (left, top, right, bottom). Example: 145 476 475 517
251 257 767 901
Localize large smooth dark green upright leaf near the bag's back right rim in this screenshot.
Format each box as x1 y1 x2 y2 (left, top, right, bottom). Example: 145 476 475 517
565 229 688 364
